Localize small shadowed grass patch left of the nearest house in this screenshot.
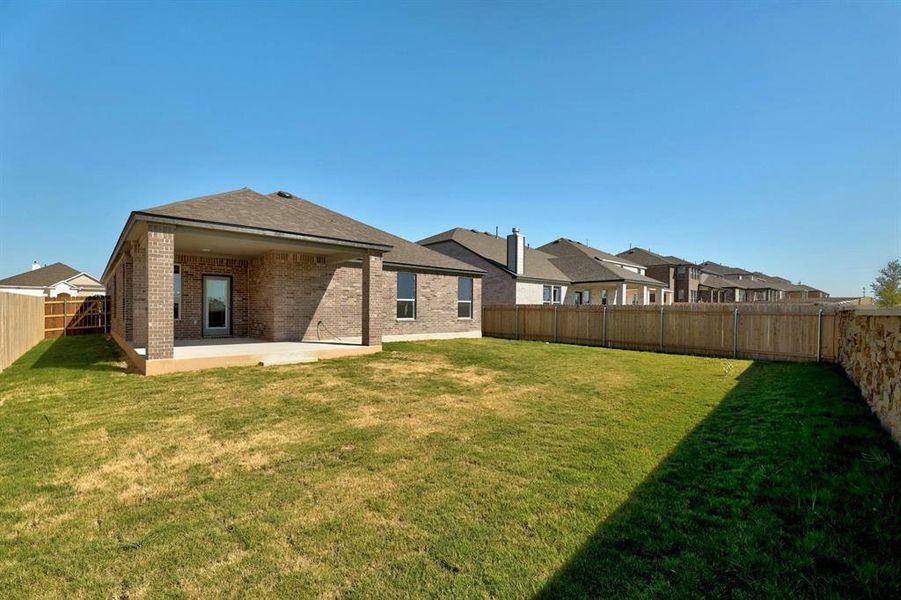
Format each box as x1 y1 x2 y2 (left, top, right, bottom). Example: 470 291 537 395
27 335 126 372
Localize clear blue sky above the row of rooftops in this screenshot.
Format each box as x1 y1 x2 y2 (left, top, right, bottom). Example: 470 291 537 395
0 2 901 295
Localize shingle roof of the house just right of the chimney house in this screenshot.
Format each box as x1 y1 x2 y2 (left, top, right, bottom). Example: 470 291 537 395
539 238 666 287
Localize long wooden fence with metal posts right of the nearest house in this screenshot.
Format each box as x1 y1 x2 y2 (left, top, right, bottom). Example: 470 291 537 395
482 304 838 361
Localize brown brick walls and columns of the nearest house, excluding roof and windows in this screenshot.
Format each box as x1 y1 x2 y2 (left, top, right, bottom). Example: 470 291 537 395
125 243 482 358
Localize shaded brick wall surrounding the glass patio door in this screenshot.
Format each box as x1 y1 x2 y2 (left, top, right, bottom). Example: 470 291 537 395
175 254 250 340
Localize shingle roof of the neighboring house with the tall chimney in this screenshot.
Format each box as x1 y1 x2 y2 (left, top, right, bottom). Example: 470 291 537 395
419 227 570 282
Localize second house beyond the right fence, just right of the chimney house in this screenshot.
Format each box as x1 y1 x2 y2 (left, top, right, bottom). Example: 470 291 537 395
538 238 672 304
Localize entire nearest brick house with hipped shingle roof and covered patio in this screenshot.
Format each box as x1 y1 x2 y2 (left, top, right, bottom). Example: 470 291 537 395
102 188 484 365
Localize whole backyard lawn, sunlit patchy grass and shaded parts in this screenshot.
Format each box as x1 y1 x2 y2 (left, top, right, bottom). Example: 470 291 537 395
0 336 901 598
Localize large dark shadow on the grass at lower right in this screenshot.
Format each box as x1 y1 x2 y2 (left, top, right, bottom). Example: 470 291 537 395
538 363 901 598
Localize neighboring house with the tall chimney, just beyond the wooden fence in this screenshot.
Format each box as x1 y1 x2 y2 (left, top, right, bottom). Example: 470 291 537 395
419 227 570 304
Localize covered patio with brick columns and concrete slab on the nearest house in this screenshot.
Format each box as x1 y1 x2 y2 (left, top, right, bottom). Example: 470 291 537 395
103 202 390 375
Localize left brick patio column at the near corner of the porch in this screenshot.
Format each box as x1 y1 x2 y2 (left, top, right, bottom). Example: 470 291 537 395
146 223 175 360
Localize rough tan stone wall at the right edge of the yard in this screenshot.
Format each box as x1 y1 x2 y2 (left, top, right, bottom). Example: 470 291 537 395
838 308 901 444
